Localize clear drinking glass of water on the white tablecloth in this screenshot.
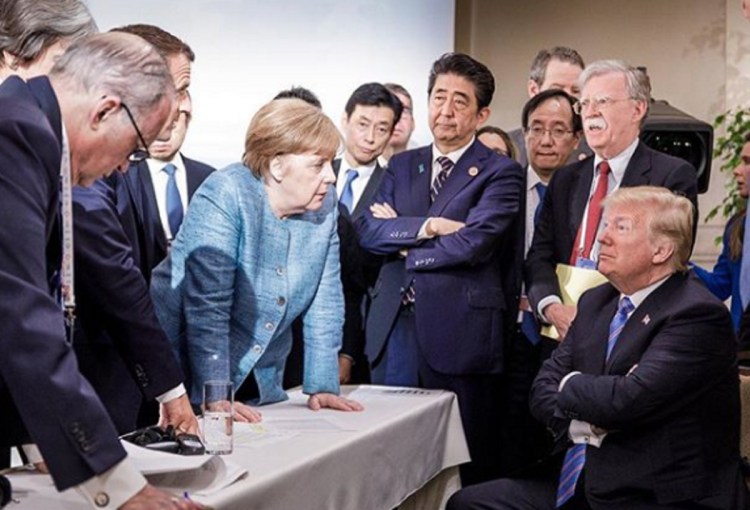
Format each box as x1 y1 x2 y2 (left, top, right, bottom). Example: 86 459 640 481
203 381 234 455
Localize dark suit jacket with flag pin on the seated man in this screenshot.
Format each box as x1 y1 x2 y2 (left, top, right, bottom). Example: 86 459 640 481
531 273 747 510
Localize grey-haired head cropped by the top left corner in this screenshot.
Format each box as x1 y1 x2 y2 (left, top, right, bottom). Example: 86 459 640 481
0 0 98 81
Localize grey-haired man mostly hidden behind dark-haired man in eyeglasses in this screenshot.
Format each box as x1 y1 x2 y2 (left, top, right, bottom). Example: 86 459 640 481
508 46 591 168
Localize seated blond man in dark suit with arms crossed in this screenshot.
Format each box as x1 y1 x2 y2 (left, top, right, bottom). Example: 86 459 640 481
448 186 748 510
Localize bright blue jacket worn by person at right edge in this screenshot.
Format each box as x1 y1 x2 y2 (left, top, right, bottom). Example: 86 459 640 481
691 215 745 333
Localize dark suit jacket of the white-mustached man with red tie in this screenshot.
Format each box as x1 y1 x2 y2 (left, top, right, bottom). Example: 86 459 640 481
525 142 698 312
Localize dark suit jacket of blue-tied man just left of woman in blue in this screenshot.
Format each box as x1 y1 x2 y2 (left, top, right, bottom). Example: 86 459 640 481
114 156 214 282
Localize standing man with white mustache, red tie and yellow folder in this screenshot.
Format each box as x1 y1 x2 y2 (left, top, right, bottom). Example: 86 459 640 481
525 60 697 340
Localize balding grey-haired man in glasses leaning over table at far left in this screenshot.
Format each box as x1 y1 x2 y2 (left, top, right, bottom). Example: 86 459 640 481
0 34 197 509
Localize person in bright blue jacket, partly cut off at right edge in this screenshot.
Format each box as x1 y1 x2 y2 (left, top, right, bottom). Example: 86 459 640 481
692 133 750 332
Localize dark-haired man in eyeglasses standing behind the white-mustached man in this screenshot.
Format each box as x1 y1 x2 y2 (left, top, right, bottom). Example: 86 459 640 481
505 89 582 474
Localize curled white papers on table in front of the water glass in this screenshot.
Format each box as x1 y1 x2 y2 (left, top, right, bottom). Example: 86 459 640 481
122 441 247 496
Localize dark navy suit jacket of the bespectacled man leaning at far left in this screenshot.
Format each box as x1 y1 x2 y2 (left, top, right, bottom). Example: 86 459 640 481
0 77 125 490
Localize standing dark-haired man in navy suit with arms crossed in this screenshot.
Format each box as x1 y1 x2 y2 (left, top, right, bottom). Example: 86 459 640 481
355 53 523 483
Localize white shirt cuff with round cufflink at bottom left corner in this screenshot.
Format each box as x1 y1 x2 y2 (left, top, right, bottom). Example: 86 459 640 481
76 457 146 510
